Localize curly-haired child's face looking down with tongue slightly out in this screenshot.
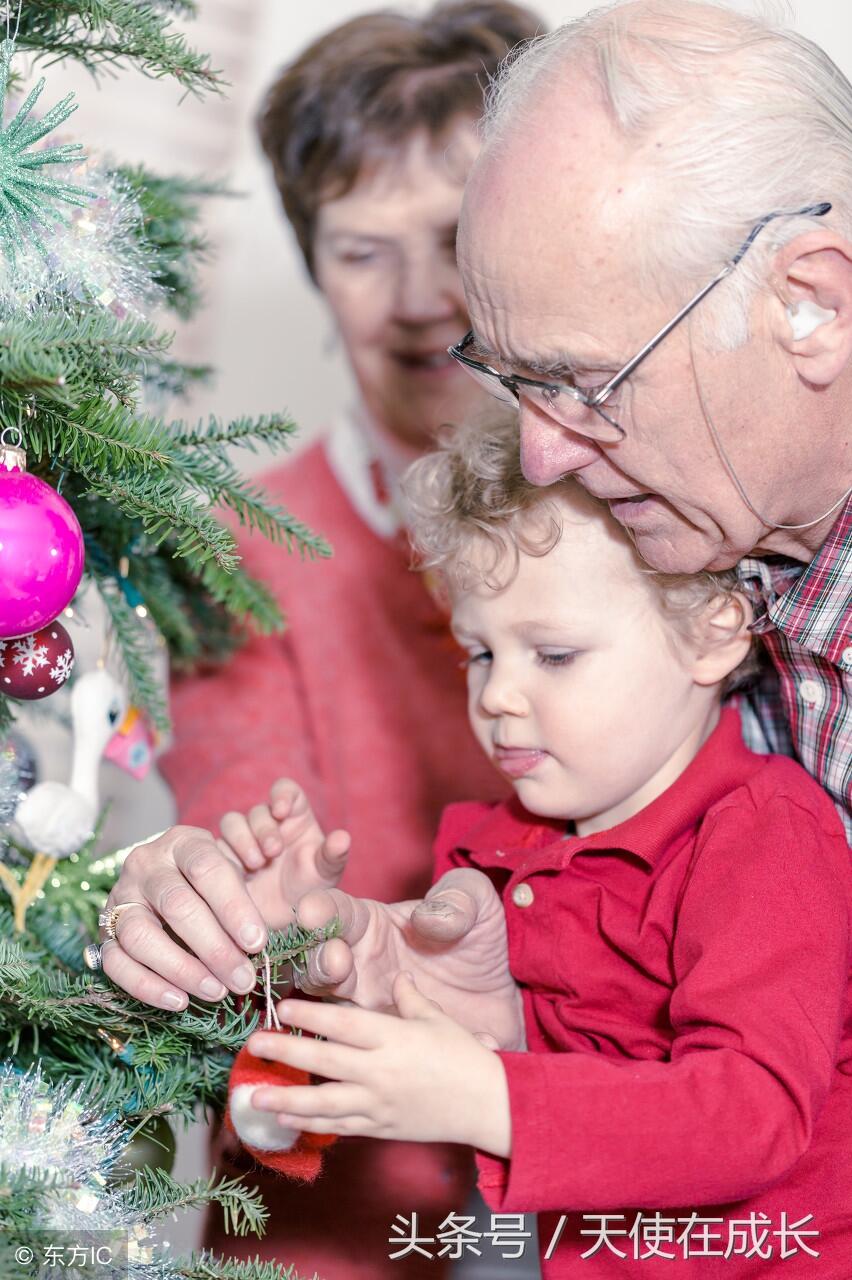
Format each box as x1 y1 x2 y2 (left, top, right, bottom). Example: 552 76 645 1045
453 503 719 835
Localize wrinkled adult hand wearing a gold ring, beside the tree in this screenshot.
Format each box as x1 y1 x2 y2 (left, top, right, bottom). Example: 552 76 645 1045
102 810 349 1009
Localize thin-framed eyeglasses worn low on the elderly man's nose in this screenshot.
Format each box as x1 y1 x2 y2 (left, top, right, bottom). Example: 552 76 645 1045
448 201 832 444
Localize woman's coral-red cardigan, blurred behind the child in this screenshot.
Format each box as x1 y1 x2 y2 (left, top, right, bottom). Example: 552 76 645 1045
160 445 505 1280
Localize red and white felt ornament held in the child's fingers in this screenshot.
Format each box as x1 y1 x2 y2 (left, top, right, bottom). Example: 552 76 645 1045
225 1032 338 1183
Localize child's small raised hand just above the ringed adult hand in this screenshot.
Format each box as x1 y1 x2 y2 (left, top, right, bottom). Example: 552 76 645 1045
219 778 349 872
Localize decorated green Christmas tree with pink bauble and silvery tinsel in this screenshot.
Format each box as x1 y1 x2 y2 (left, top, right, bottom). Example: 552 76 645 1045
0 0 329 1280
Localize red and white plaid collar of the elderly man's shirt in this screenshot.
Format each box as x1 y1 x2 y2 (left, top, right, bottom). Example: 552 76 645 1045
738 494 852 671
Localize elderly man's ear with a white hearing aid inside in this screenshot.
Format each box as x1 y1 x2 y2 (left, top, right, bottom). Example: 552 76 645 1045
771 230 852 387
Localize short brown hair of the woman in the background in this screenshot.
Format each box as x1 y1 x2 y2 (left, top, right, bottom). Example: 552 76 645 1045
257 0 545 275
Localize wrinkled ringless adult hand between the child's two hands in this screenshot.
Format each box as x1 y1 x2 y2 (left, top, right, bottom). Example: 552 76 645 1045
291 868 525 1050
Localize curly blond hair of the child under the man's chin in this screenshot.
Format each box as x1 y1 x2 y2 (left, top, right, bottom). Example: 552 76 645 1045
403 410 757 691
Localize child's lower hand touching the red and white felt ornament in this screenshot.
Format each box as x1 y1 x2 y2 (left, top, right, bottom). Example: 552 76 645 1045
247 973 512 1156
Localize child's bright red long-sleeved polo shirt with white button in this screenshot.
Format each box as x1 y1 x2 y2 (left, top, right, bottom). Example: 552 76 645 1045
436 710 852 1280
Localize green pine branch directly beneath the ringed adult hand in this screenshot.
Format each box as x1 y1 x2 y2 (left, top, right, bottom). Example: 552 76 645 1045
0 911 338 1123
